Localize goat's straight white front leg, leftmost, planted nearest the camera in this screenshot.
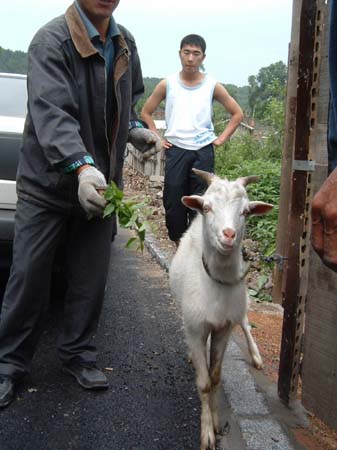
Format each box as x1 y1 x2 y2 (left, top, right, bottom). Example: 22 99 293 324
187 334 216 450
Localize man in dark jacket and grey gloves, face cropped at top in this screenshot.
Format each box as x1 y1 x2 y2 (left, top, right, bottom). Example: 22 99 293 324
0 0 156 407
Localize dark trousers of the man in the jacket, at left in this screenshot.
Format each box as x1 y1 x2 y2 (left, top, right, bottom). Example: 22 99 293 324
0 199 111 378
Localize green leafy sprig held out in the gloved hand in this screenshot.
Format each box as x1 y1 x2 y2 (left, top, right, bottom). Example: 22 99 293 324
103 181 152 251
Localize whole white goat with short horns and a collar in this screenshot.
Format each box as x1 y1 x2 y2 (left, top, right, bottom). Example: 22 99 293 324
170 169 272 450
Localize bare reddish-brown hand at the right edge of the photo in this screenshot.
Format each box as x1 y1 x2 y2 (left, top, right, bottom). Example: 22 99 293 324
311 169 337 272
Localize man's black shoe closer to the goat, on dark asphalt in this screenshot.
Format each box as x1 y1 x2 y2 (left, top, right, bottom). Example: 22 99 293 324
63 363 109 389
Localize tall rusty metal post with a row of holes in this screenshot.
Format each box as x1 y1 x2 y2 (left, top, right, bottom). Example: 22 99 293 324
278 0 316 404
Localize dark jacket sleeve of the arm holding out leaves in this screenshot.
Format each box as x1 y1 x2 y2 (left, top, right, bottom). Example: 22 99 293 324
27 44 89 172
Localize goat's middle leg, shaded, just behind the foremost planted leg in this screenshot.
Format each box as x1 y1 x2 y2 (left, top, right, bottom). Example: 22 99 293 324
209 322 233 433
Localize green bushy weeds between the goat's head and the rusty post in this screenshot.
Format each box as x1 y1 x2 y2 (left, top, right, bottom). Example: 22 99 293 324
215 135 282 256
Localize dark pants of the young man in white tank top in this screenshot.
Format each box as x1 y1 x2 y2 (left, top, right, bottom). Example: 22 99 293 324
163 144 214 241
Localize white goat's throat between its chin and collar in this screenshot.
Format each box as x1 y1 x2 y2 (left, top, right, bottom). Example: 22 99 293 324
202 243 244 284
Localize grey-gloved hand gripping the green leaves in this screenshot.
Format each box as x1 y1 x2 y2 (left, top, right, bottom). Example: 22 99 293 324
78 166 107 218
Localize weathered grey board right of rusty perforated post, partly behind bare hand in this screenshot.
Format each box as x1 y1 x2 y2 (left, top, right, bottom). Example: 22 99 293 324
301 0 337 431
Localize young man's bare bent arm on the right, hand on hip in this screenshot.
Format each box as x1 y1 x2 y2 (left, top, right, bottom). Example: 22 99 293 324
213 83 243 146
